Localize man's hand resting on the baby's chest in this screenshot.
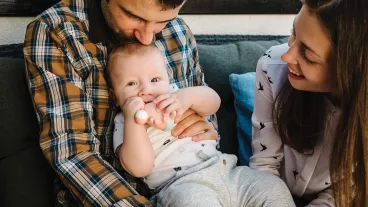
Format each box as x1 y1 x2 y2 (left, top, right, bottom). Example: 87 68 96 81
171 109 218 141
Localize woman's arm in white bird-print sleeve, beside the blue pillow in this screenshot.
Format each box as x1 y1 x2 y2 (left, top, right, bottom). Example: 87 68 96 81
249 58 284 176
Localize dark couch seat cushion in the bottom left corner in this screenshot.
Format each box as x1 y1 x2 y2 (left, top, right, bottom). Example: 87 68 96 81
0 145 55 207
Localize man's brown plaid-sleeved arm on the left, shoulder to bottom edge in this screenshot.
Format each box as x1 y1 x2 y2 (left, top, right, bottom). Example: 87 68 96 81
24 20 149 206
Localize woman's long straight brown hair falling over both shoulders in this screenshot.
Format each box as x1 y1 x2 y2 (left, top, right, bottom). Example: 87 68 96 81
273 0 368 207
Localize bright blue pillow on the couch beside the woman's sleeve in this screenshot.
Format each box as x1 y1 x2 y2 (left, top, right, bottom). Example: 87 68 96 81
229 72 256 165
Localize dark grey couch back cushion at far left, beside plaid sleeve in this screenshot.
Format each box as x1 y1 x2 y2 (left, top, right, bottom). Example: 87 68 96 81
0 58 39 159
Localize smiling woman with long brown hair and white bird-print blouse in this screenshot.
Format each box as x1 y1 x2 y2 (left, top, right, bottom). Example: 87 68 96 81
250 0 368 206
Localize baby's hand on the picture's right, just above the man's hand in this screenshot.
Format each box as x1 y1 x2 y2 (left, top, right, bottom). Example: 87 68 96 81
153 94 182 120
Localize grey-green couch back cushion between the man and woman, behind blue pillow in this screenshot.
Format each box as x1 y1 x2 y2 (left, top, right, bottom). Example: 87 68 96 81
198 38 287 154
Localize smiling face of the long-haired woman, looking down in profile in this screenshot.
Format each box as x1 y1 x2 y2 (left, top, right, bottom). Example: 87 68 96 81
281 5 332 92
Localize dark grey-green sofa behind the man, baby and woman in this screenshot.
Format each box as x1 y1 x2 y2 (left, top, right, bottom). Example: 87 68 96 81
0 35 287 207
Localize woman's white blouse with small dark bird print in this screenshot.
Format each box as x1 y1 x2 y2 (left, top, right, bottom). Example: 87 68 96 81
249 44 340 206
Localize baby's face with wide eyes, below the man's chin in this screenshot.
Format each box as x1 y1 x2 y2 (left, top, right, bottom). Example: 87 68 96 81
110 50 170 107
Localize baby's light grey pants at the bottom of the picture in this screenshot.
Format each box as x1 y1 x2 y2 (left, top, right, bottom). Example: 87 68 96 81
151 151 295 207
